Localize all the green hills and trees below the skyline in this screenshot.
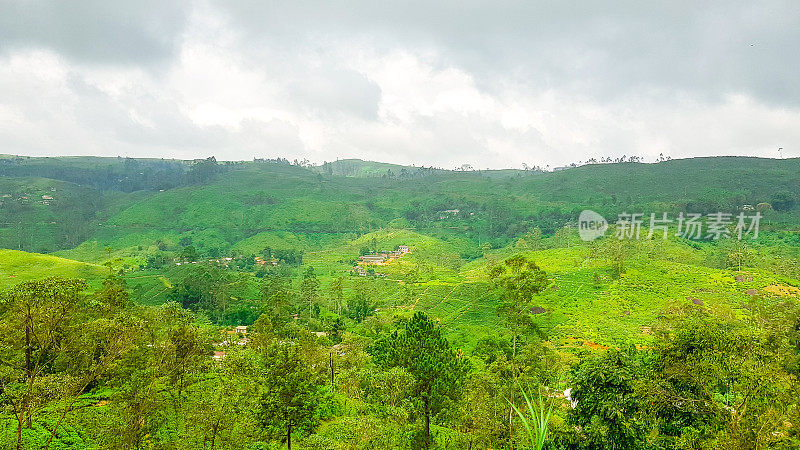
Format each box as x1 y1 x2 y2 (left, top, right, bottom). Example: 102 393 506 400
0 157 800 449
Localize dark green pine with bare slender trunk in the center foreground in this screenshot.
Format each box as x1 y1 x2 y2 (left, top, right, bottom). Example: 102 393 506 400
371 312 471 448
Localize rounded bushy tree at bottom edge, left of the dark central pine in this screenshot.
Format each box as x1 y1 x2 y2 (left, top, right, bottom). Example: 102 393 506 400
260 342 320 450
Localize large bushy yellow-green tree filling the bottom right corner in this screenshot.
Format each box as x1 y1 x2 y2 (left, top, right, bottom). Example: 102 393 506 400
647 308 800 448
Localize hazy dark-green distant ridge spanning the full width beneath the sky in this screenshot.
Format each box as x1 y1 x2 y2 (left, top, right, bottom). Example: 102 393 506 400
0 157 800 262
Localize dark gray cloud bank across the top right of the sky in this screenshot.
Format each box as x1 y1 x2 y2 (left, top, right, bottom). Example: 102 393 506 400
222 0 800 106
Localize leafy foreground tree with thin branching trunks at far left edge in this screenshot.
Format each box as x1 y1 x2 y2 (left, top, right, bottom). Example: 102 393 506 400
0 277 131 448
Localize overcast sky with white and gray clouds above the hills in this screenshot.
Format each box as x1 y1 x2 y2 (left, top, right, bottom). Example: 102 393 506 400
0 0 800 168
